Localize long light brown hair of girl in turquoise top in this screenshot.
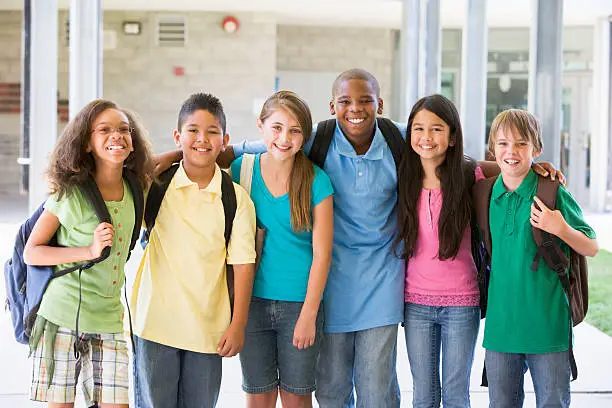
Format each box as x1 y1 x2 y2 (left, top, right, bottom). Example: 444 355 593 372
259 91 314 232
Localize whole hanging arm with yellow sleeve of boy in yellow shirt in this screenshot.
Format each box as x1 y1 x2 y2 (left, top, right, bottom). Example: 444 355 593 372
217 184 255 357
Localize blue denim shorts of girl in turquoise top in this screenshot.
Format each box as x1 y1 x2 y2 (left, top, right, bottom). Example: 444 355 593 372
240 297 323 395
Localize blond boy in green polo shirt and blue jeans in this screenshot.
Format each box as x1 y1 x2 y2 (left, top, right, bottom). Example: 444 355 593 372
483 109 598 408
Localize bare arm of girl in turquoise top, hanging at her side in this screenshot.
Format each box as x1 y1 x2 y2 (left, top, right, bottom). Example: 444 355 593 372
293 196 334 349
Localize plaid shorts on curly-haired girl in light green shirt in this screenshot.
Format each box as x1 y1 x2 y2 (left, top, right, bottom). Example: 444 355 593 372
30 327 129 406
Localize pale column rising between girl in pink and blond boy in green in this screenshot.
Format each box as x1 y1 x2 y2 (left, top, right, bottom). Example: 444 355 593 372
460 0 488 160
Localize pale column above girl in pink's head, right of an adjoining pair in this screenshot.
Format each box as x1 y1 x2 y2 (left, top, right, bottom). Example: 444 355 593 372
419 0 442 96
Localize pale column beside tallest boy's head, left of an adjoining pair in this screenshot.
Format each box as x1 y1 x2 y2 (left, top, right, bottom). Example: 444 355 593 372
400 0 421 118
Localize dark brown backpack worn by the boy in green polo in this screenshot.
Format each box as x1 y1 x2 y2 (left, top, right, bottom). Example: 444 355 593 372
472 176 589 386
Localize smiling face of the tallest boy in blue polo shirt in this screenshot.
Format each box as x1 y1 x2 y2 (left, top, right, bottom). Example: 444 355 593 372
329 79 383 145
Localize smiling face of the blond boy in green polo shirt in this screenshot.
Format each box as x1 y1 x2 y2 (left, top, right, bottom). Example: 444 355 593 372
494 127 542 180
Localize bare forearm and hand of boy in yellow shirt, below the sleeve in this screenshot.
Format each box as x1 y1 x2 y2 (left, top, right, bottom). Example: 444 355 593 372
217 264 255 357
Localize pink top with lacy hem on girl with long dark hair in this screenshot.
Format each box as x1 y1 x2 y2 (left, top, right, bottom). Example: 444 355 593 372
404 167 484 306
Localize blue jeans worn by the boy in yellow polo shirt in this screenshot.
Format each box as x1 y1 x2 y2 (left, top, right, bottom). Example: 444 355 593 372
134 336 221 408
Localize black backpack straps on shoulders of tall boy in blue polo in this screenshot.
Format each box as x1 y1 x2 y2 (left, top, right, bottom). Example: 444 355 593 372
308 118 406 170
